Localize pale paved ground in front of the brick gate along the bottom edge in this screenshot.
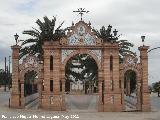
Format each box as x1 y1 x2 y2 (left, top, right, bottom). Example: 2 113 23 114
0 92 160 120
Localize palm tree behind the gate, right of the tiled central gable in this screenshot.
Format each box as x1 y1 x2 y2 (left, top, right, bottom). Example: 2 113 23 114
93 25 135 63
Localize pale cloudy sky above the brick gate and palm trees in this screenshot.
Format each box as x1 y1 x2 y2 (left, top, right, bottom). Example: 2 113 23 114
0 0 160 83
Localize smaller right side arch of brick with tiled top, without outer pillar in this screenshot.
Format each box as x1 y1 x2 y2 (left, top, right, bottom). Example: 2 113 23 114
120 55 142 111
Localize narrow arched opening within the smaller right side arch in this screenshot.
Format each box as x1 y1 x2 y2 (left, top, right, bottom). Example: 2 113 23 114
124 70 137 110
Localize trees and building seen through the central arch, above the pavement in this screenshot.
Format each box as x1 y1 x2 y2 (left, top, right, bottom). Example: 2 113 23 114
65 54 98 94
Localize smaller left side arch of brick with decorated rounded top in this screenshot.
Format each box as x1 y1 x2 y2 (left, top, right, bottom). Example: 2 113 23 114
18 55 43 108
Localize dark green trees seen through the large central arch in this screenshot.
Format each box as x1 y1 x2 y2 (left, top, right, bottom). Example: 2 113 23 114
65 54 98 91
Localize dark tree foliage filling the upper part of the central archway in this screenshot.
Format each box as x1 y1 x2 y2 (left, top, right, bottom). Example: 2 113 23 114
66 54 98 81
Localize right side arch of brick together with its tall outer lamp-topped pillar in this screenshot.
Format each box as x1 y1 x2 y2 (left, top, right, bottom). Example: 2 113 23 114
120 52 151 111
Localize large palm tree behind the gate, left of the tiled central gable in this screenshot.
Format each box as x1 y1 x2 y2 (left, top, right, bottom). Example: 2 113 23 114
20 16 65 58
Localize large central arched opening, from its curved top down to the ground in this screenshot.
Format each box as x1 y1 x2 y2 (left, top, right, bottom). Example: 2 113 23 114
65 54 98 111
